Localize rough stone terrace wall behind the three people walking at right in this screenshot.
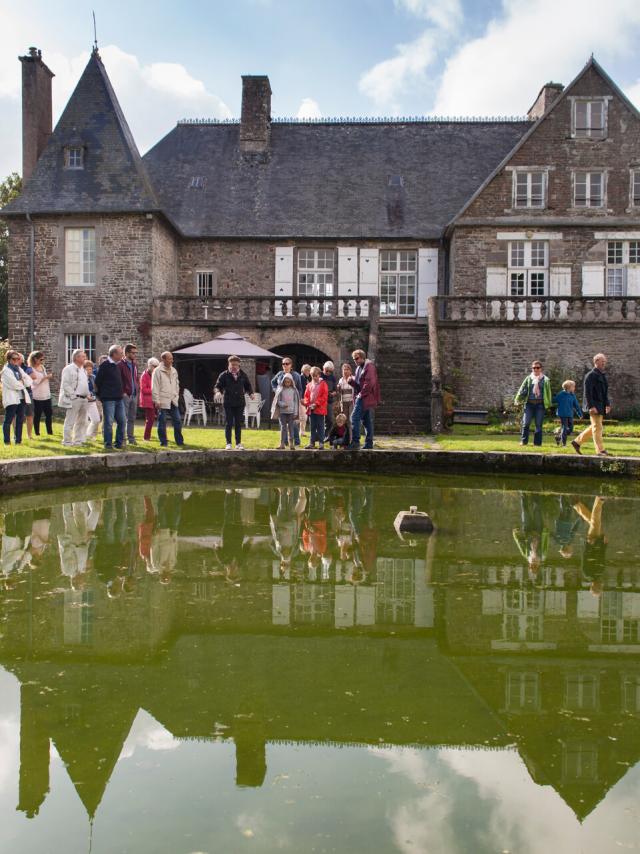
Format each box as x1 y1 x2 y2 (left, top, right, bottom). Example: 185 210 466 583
438 323 640 415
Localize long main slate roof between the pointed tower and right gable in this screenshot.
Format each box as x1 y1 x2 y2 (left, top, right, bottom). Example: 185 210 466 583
143 121 531 239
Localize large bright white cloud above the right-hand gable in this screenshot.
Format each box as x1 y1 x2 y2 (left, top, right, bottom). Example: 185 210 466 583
433 0 640 115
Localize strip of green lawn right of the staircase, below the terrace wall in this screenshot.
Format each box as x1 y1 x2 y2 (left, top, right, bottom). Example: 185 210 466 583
436 421 640 457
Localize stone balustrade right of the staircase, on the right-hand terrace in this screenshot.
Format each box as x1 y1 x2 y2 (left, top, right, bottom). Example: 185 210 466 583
436 296 640 324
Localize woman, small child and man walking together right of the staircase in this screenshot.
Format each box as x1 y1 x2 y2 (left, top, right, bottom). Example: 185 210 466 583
515 353 611 456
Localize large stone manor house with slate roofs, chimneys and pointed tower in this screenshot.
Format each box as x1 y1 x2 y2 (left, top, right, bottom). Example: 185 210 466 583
2 48 640 431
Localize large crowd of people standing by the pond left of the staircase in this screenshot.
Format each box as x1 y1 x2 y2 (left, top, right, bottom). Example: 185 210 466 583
0 344 380 450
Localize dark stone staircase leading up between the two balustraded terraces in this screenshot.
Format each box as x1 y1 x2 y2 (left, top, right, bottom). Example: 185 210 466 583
375 320 431 434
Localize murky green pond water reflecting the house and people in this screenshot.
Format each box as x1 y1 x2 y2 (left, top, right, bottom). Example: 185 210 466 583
0 476 640 854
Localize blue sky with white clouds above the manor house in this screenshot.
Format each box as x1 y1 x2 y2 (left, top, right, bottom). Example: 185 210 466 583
0 0 640 177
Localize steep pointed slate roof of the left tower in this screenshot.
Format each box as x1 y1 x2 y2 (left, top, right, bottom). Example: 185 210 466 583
2 52 158 214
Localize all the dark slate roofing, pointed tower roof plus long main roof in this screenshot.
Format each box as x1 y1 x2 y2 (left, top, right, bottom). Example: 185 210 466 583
3 52 531 240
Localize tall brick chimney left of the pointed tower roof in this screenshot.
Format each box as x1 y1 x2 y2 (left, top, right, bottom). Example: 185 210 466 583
18 47 54 181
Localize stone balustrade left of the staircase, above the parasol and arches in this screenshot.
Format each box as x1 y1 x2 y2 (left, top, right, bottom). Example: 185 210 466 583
153 296 378 324
